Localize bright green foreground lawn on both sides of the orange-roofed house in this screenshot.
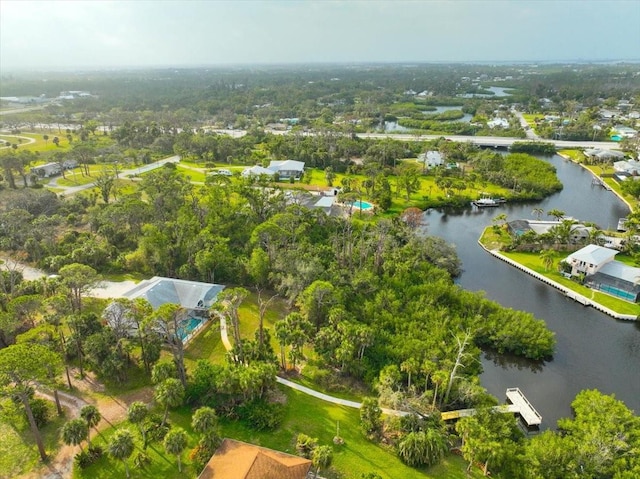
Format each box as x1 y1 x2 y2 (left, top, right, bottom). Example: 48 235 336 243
73 388 481 479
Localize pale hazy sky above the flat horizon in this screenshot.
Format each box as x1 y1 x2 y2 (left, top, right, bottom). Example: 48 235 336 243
0 0 640 72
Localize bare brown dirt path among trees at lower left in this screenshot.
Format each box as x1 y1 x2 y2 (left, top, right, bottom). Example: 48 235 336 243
20 375 153 479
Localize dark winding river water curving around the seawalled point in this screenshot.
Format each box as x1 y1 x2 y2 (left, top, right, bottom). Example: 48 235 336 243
425 156 640 428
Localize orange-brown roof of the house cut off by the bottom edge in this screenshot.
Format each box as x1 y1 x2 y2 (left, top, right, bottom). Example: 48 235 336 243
198 439 311 479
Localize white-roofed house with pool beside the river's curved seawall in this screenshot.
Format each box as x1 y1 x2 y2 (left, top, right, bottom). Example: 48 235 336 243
565 245 640 303
